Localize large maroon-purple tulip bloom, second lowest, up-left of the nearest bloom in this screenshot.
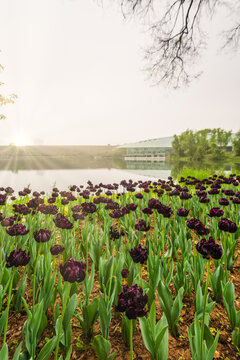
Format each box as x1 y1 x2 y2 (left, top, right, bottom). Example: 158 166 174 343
60 258 86 283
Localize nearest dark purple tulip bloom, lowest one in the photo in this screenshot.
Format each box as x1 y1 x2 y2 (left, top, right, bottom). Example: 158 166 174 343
115 284 148 320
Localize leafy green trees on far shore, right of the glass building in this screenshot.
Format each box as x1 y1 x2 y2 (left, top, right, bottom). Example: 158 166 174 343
172 128 240 160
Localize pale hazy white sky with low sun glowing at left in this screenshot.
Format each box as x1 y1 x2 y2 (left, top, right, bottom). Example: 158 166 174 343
0 0 240 145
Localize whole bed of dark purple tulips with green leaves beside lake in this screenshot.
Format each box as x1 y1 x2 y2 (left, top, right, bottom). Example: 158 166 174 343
0 174 240 360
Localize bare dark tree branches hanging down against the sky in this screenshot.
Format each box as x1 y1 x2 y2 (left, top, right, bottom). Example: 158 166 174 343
120 0 240 87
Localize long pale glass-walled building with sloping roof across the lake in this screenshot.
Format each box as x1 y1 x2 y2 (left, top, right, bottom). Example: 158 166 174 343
118 136 173 161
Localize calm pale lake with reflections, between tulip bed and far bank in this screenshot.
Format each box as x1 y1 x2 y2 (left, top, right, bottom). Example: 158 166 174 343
0 156 240 191
